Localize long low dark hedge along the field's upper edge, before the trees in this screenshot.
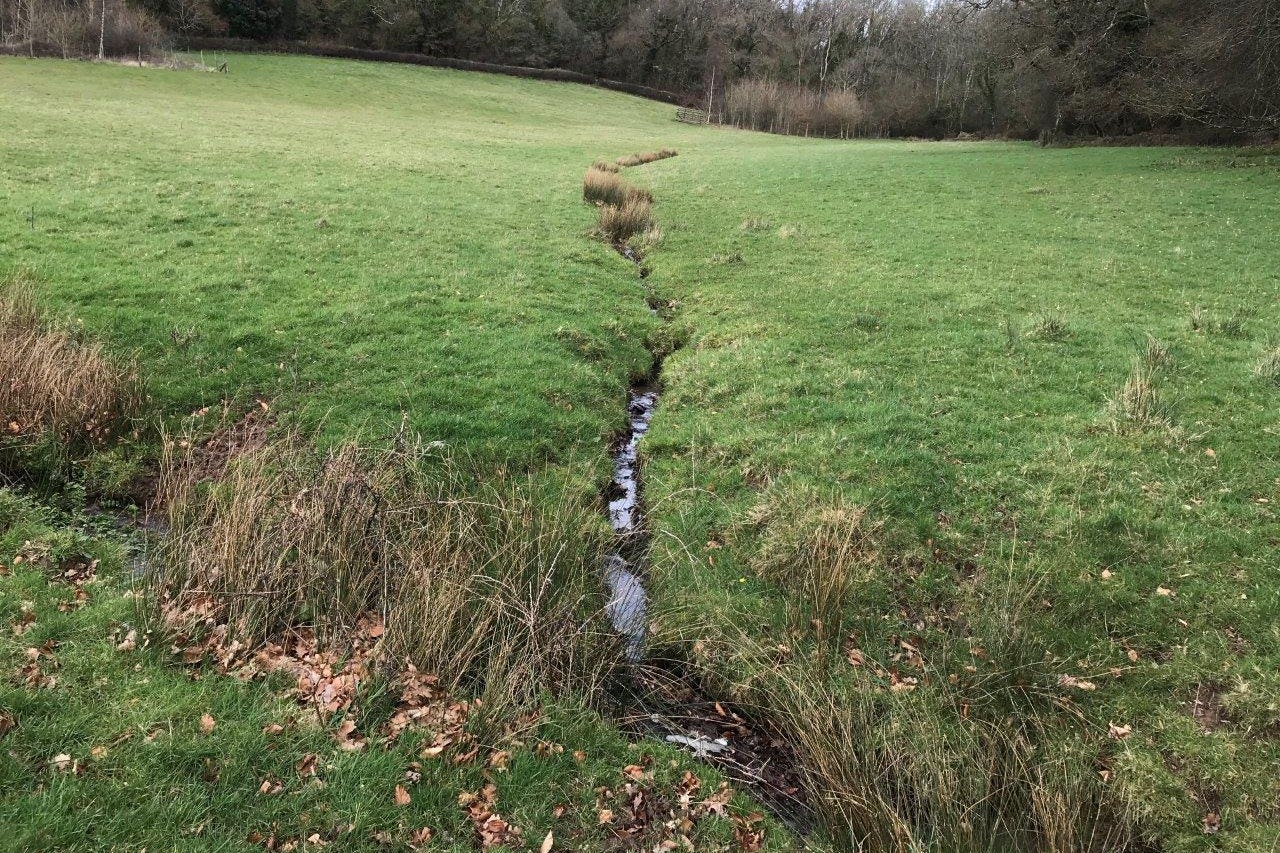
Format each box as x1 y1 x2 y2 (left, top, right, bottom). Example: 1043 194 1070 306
178 37 687 106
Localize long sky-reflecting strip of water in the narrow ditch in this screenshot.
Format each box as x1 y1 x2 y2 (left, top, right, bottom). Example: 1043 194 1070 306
604 386 658 661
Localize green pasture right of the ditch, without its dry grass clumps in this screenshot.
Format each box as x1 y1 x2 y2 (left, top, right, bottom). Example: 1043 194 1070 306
645 142 1280 849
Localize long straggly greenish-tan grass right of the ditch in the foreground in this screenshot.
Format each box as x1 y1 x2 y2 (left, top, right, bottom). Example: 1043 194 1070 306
670 550 1132 853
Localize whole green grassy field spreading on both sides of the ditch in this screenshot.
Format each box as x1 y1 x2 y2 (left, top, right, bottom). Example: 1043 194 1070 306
0 56 1280 852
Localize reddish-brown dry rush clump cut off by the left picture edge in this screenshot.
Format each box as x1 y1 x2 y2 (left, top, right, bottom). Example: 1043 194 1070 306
0 275 142 447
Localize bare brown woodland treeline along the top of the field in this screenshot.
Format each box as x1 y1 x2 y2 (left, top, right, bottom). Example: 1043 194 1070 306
0 0 1280 140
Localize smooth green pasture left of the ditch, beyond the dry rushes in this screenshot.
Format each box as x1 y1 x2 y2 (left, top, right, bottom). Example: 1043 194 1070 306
0 56 667 457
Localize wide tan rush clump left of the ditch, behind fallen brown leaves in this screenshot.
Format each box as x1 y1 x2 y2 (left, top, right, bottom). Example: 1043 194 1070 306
154 427 617 713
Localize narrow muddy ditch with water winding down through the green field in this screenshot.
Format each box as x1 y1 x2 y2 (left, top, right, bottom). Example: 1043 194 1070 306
586 156 813 834
